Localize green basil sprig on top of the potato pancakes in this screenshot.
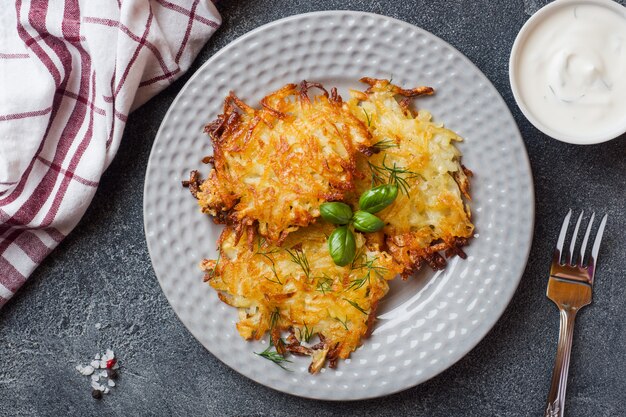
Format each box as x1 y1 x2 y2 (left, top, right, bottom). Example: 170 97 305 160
320 184 398 266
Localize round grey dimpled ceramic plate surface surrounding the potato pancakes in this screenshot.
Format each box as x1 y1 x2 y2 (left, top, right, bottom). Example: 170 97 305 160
144 11 534 400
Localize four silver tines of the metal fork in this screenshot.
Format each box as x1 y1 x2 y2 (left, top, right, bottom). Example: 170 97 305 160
554 209 607 271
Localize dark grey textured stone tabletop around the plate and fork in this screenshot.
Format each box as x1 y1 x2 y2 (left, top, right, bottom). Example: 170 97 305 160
0 0 626 417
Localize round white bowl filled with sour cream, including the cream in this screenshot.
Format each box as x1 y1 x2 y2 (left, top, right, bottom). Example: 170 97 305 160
509 0 626 145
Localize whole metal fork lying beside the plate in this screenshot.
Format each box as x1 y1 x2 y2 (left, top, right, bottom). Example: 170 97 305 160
545 210 607 417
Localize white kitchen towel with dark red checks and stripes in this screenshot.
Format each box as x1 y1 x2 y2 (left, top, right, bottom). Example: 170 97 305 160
0 0 221 306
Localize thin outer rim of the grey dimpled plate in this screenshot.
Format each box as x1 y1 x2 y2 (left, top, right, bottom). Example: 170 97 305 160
143 10 535 401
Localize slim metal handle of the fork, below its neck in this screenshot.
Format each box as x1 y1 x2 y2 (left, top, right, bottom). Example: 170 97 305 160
544 309 578 417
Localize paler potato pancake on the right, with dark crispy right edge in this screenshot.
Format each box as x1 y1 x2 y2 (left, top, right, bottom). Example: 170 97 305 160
347 78 474 277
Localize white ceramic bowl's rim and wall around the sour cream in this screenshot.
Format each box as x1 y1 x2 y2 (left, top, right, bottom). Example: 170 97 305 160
509 0 626 145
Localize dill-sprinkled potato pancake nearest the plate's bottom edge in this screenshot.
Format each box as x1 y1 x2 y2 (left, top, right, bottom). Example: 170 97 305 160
201 223 400 373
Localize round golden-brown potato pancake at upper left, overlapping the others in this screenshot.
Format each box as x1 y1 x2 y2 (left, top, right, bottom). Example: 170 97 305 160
192 81 372 244
